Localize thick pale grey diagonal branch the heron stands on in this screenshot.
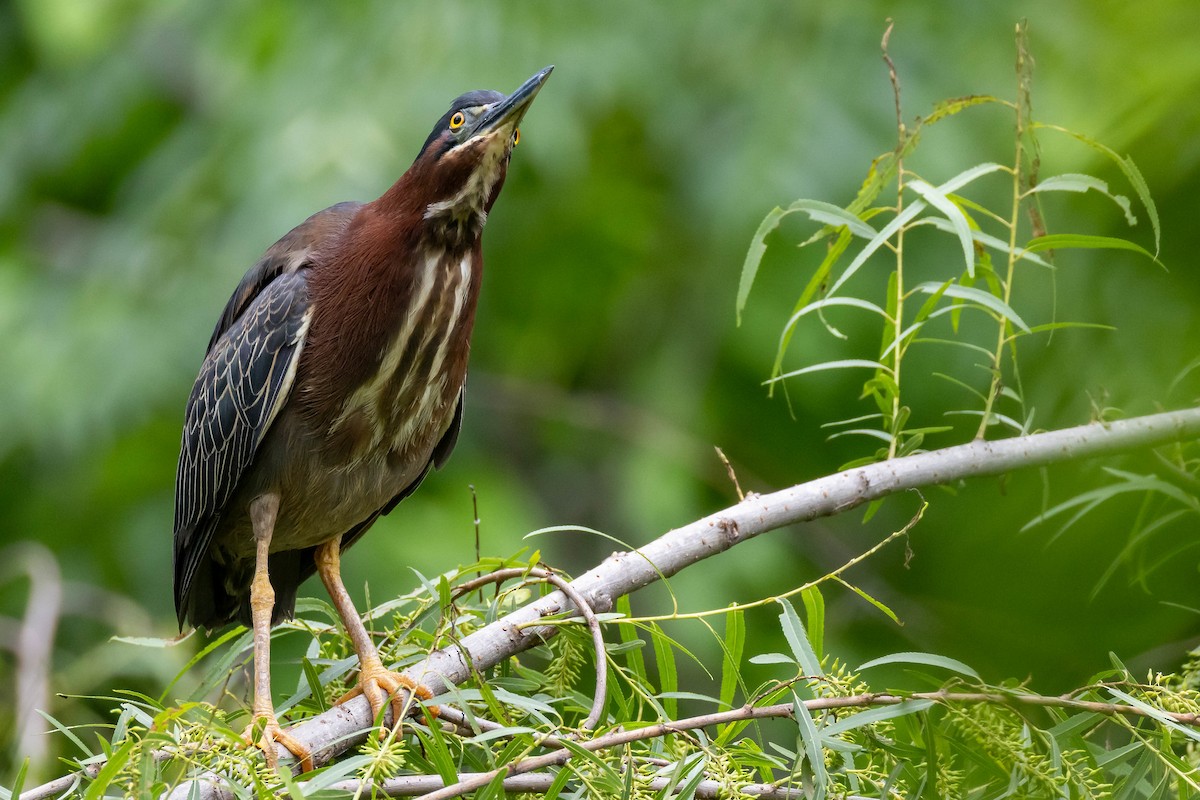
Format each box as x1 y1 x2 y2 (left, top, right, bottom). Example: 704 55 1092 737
21 409 1200 798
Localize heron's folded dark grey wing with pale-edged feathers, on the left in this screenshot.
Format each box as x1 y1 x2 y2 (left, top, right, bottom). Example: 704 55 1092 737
174 203 360 626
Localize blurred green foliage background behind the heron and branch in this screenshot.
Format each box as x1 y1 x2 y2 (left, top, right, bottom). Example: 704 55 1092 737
0 0 1200 777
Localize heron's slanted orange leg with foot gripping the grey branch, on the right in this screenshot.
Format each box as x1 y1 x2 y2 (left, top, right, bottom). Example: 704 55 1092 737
316 537 437 727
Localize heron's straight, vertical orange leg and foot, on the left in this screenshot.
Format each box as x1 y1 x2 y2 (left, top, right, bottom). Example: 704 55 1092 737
242 494 312 772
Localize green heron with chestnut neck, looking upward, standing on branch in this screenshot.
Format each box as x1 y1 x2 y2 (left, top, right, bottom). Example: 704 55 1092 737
175 67 553 765
